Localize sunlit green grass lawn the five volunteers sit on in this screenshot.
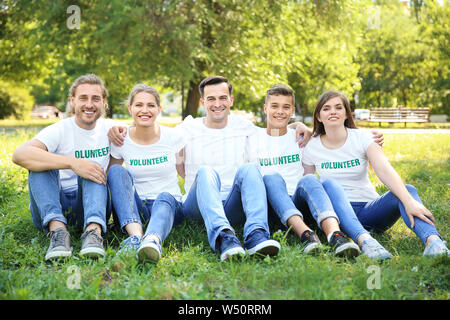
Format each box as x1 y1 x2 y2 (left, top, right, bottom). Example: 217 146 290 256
0 128 450 300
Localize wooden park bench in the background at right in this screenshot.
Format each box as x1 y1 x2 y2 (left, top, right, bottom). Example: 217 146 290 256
368 107 430 127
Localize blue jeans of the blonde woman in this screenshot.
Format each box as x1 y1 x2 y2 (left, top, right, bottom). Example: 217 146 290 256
108 165 183 242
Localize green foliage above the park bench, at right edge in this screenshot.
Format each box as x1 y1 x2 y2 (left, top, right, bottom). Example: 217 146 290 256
356 1 450 114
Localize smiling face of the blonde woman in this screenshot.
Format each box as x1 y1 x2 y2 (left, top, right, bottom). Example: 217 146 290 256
128 91 161 127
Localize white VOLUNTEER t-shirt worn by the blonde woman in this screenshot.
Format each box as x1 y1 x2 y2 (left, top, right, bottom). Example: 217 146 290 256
111 125 185 201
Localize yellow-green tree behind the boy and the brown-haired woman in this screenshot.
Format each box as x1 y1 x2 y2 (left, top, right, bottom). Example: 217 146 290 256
262 0 362 116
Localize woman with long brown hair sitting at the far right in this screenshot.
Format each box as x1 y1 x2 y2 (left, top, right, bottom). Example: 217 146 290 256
303 91 449 258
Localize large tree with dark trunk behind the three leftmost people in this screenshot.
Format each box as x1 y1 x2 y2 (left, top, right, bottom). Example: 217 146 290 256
0 0 288 116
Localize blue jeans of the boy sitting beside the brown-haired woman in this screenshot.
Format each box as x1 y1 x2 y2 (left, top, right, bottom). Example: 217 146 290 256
263 173 339 228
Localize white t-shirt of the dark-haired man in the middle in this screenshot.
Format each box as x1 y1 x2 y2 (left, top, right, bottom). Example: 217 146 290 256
176 115 257 200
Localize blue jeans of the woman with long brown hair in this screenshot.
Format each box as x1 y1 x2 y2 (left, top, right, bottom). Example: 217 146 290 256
323 180 440 244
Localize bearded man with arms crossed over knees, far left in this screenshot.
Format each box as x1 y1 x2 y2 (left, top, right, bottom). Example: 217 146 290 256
12 74 112 260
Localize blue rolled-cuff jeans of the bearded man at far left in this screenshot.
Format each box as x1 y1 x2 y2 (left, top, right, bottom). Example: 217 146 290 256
28 170 111 233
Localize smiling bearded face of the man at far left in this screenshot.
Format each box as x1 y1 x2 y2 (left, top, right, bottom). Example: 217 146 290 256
70 83 106 130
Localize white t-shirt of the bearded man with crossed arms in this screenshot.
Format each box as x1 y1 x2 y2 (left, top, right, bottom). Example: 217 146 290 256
35 117 114 191
